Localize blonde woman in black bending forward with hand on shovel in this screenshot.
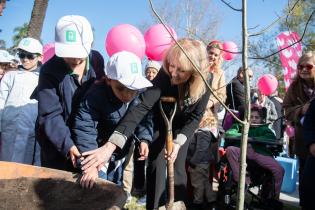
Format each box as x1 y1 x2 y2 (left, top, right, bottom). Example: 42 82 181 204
82 38 209 209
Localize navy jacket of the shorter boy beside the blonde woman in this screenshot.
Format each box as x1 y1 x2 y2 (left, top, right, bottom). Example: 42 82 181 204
71 81 153 155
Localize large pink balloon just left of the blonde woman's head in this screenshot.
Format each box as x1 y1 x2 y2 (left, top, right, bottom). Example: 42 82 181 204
144 24 177 61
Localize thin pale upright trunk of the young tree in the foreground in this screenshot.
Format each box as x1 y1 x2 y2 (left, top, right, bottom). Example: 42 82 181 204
236 0 250 210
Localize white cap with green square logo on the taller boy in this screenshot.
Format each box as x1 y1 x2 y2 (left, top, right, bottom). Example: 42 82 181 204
55 15 93 58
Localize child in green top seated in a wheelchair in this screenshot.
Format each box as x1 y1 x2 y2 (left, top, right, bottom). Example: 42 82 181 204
224 106 284 208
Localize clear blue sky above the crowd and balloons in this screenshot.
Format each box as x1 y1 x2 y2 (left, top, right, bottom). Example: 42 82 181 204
0 0 287 77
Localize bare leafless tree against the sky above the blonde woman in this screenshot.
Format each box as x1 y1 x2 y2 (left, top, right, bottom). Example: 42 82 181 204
138 0 220 43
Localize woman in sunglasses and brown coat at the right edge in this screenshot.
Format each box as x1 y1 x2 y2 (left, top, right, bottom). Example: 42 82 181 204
283 51 315 205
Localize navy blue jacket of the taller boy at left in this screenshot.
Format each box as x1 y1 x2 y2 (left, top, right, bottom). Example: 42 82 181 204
36 56 95 170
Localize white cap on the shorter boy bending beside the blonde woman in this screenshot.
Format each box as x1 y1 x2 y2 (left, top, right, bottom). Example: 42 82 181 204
105 51 152 90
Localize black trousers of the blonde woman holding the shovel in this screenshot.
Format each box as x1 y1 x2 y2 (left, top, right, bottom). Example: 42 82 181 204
146 138 189 210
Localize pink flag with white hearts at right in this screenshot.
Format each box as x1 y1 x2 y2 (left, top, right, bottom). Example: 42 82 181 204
277 31 302 90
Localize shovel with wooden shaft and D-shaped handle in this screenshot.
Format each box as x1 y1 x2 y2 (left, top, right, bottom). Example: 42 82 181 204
160 97 177 210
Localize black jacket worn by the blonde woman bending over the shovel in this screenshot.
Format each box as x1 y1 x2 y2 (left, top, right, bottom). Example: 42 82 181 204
116 69 210 146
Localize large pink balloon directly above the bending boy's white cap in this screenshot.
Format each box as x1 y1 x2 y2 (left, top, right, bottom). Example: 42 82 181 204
105 24 145 59
